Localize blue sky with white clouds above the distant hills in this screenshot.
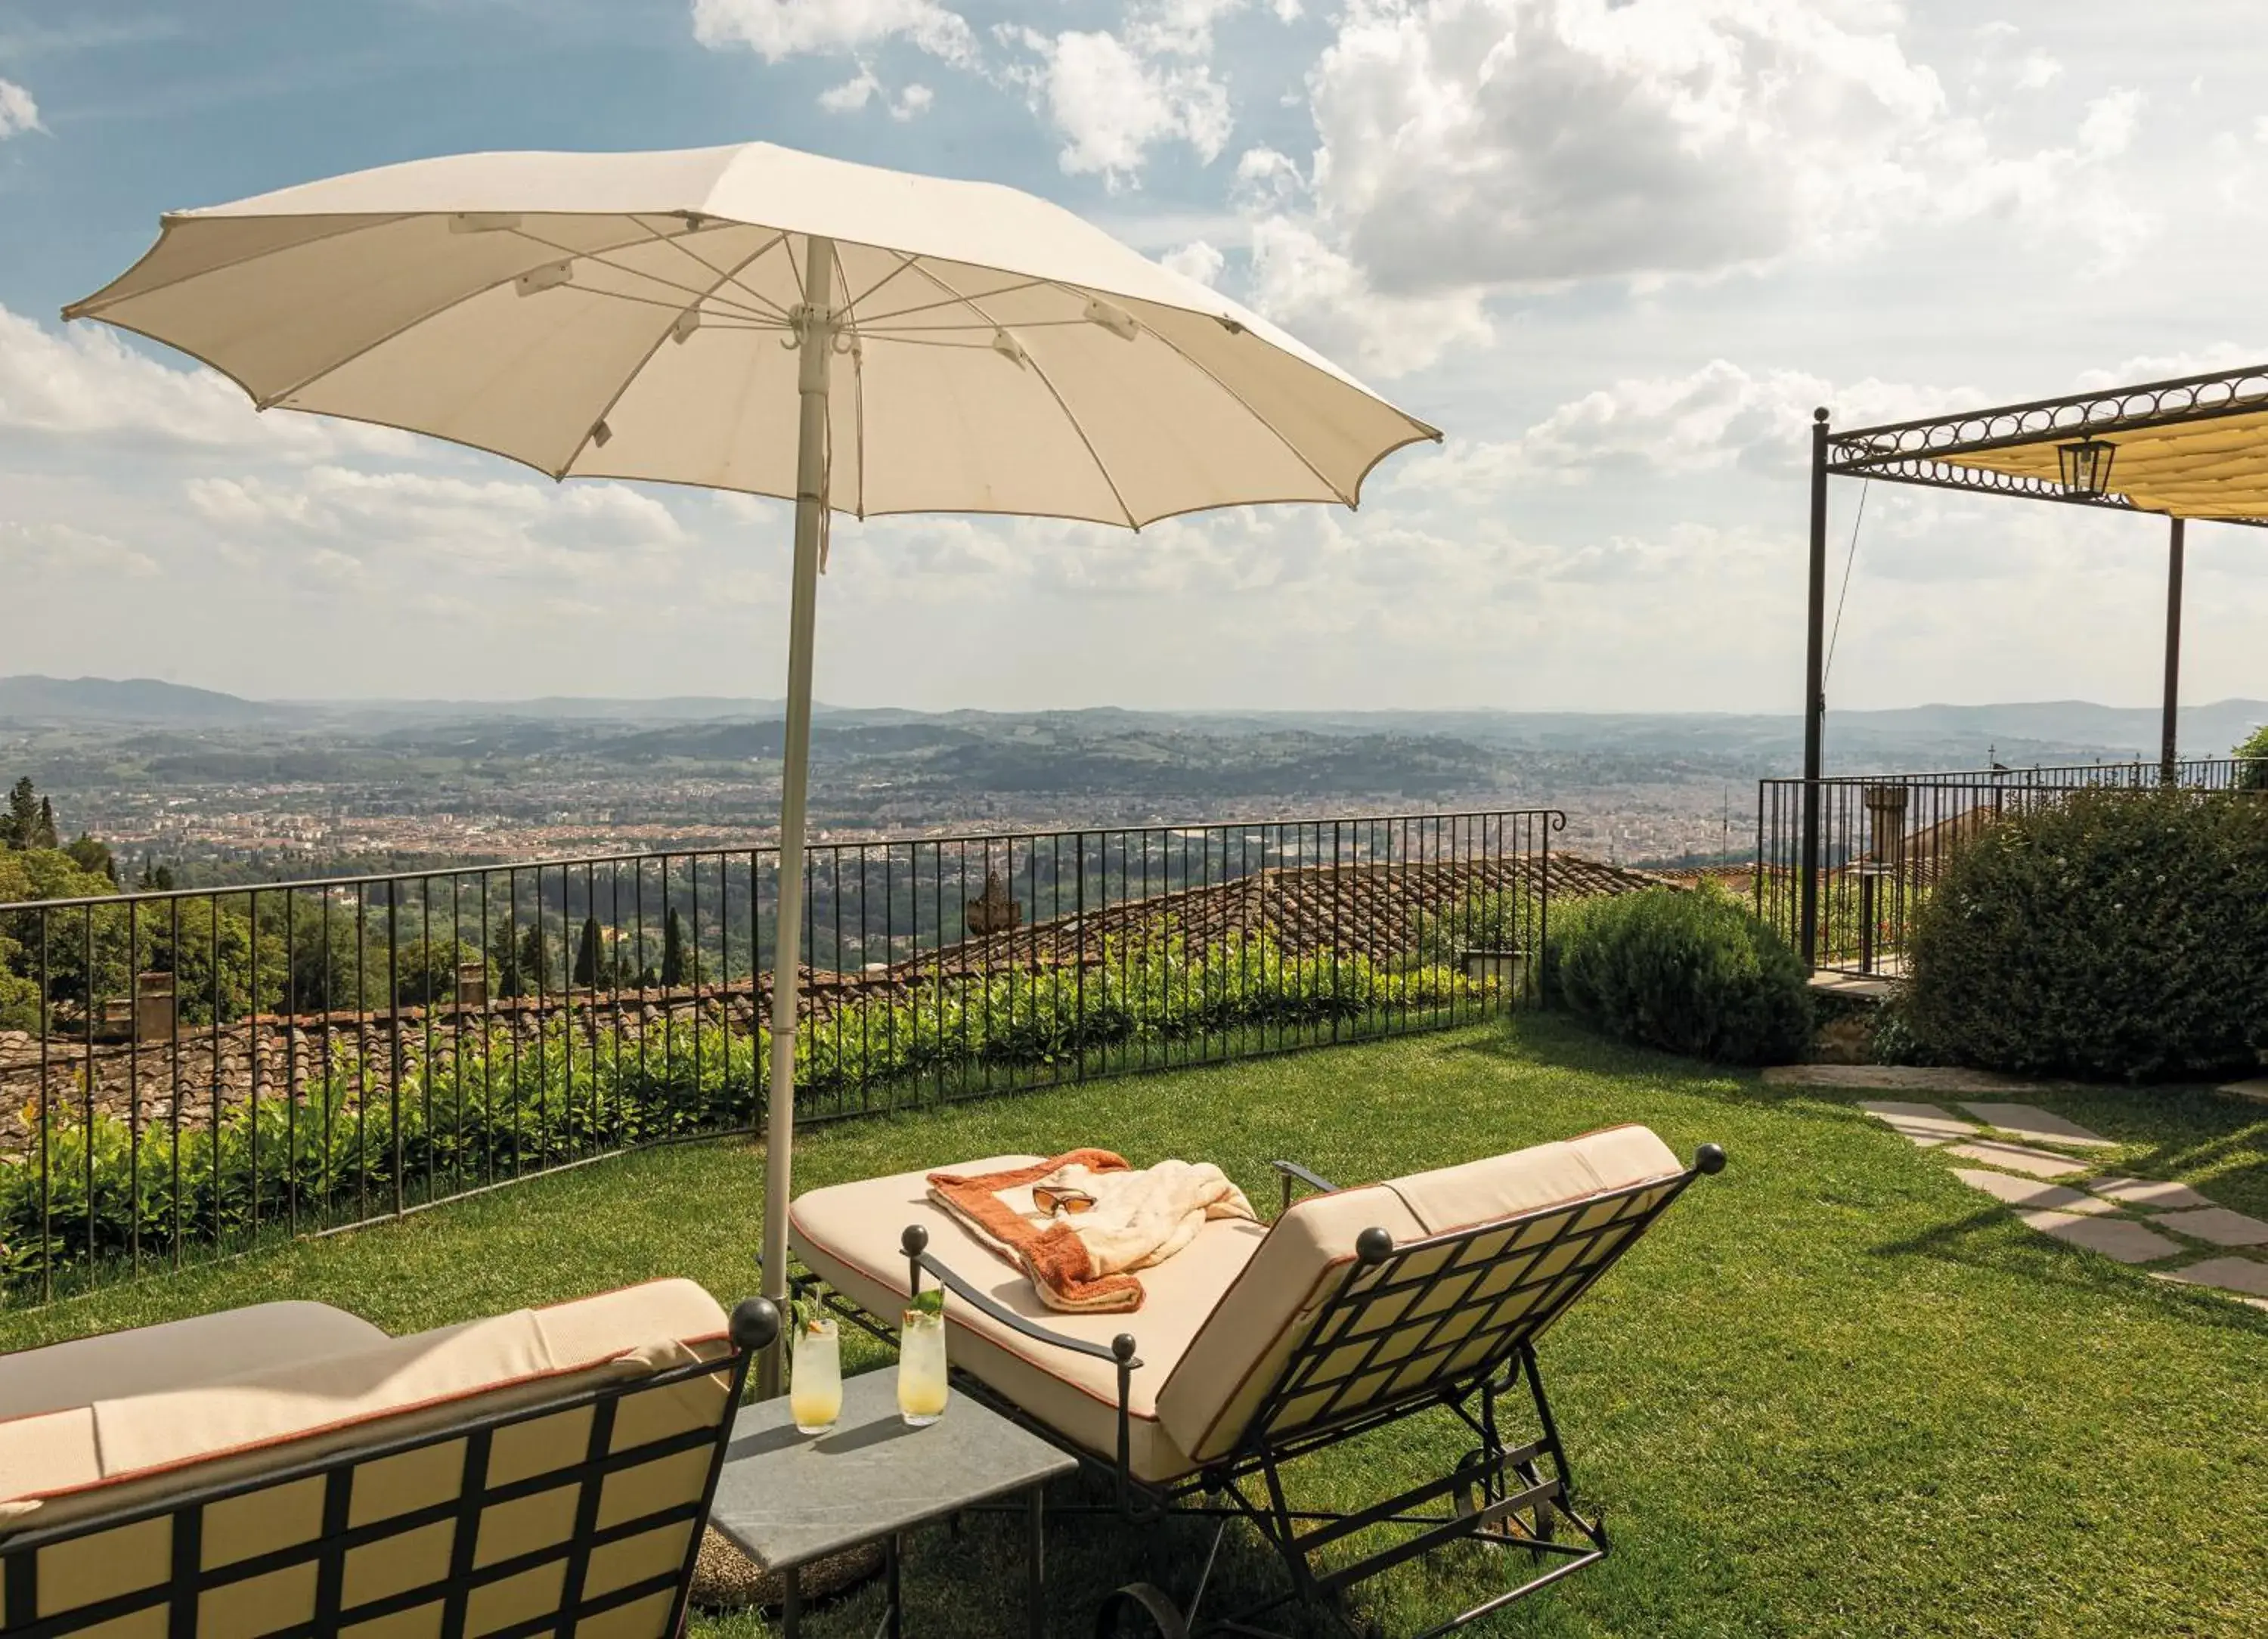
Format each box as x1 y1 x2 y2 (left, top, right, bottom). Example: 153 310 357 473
0 0 2268 710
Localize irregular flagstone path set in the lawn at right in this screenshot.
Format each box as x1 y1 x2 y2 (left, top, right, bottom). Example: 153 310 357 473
1851 1097 2268 1310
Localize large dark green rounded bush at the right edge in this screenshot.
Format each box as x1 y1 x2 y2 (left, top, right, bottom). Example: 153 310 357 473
1905 792 2268 1079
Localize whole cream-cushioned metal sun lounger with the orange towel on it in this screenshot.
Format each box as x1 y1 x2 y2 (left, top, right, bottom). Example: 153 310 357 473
789 1126 1724 1634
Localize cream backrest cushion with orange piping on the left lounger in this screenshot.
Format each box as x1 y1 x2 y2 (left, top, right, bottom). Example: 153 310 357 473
0 1281 728 1528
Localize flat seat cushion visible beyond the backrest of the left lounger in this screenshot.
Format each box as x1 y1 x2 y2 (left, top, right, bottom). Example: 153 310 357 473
0 1303 388 1417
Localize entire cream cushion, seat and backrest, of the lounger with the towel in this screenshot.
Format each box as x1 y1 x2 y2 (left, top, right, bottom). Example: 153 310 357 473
789 1126 1683 1483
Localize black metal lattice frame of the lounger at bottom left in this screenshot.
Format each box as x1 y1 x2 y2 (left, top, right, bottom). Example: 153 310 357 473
0 1299 780 1639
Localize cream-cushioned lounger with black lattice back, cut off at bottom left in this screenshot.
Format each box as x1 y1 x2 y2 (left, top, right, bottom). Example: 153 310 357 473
0 1281 778 1639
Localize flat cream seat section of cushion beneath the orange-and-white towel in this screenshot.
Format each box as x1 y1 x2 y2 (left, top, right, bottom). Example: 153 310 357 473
787 1156 1266 1483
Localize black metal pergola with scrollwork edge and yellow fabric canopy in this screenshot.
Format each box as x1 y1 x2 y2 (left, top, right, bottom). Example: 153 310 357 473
1801 365 2268 961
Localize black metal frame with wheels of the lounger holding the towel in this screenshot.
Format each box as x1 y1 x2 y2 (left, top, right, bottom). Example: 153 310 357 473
798 1145 1724 1639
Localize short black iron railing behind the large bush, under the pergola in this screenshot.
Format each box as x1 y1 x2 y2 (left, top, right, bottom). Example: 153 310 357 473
1755 758 2268 977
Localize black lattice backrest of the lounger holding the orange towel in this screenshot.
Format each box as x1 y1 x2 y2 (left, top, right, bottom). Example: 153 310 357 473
1250 1172 1694 1446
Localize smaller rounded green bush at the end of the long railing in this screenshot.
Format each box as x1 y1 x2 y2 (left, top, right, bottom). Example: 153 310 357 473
1545 888 1812 1063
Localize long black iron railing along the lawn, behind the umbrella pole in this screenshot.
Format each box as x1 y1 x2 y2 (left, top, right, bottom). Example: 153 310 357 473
0 810 1565 1299
